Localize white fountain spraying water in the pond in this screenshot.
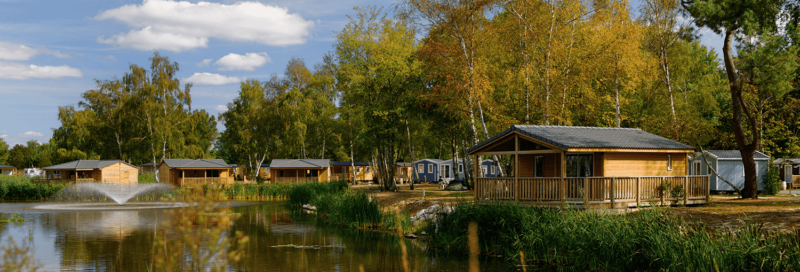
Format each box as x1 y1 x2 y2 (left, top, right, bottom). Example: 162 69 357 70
33 183 188 210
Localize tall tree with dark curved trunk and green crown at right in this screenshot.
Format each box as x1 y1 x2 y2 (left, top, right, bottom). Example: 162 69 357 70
682 0 796 198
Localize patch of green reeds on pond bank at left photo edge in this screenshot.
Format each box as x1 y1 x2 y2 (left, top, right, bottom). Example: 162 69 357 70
0 175 68 200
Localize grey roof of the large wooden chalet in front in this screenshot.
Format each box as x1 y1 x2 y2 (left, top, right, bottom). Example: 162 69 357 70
467 125 694 152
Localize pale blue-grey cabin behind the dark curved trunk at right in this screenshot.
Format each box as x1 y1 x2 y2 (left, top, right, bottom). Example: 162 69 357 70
689 150 770 192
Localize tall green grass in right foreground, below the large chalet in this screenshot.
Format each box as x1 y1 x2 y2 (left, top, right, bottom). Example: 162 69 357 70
426 203 800 271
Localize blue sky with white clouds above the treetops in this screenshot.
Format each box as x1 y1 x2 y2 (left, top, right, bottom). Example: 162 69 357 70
0 0 722 146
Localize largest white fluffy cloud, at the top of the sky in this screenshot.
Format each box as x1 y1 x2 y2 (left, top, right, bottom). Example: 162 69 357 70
95 0 314 52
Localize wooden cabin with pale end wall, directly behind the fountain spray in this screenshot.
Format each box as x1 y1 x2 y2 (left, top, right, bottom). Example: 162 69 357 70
41 160 139 184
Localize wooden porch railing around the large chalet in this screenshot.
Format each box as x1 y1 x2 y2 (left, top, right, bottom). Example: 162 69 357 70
475 176 709 207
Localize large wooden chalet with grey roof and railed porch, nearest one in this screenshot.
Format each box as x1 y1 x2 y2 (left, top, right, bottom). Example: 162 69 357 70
467 125 709 208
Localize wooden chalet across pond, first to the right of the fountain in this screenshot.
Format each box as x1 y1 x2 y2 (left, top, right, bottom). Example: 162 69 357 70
158 159 233 186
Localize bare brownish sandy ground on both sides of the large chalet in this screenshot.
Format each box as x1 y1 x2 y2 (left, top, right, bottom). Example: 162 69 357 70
353 184 800 231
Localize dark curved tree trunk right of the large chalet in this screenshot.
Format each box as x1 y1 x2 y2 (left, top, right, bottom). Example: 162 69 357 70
722 30 760 198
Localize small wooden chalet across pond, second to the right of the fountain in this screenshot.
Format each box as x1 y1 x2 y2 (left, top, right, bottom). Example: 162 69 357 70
269 159 331 183
